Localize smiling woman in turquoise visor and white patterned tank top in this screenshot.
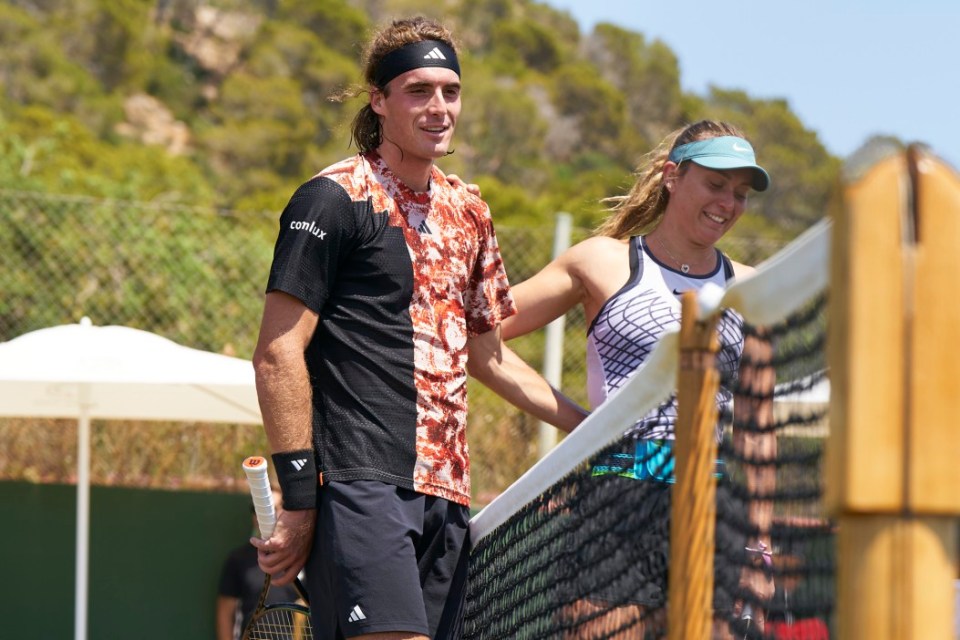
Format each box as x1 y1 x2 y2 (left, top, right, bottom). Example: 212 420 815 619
503 120 776 638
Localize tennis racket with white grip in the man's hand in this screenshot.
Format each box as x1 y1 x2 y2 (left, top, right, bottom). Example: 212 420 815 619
243 456 313 640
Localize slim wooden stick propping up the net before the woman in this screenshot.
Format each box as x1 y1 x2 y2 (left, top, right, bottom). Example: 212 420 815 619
667 291 720 640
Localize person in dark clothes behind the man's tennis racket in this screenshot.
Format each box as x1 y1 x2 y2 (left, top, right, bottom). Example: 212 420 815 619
216 491 298 640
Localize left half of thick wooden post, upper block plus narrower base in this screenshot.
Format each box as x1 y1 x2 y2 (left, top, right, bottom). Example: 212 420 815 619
826 148 909 640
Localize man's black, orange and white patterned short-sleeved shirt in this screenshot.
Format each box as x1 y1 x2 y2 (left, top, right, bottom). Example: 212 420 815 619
267 153 516 505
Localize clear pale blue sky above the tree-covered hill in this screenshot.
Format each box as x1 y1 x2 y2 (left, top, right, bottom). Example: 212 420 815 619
545 0 960 170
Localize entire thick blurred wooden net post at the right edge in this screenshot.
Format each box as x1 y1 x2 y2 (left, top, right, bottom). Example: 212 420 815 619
827 149 960 640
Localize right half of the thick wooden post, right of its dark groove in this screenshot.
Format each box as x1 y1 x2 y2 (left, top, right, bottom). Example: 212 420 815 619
904 145 960 638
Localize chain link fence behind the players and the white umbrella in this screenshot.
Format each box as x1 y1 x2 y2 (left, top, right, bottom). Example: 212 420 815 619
0 190 779 504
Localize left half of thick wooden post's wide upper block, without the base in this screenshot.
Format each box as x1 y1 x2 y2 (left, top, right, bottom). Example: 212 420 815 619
826 151 909 513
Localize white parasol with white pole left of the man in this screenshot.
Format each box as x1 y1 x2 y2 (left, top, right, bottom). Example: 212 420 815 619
0 318 261 640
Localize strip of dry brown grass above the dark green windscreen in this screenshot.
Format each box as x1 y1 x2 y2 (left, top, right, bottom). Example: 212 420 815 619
0 402 538 507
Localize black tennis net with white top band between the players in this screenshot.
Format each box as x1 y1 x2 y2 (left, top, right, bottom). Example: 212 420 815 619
462 222 834 640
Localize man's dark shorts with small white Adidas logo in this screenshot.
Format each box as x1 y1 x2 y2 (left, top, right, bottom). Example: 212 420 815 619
306 480 470 640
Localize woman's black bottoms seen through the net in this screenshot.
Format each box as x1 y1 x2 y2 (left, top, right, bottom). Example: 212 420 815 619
567 474 747 614
